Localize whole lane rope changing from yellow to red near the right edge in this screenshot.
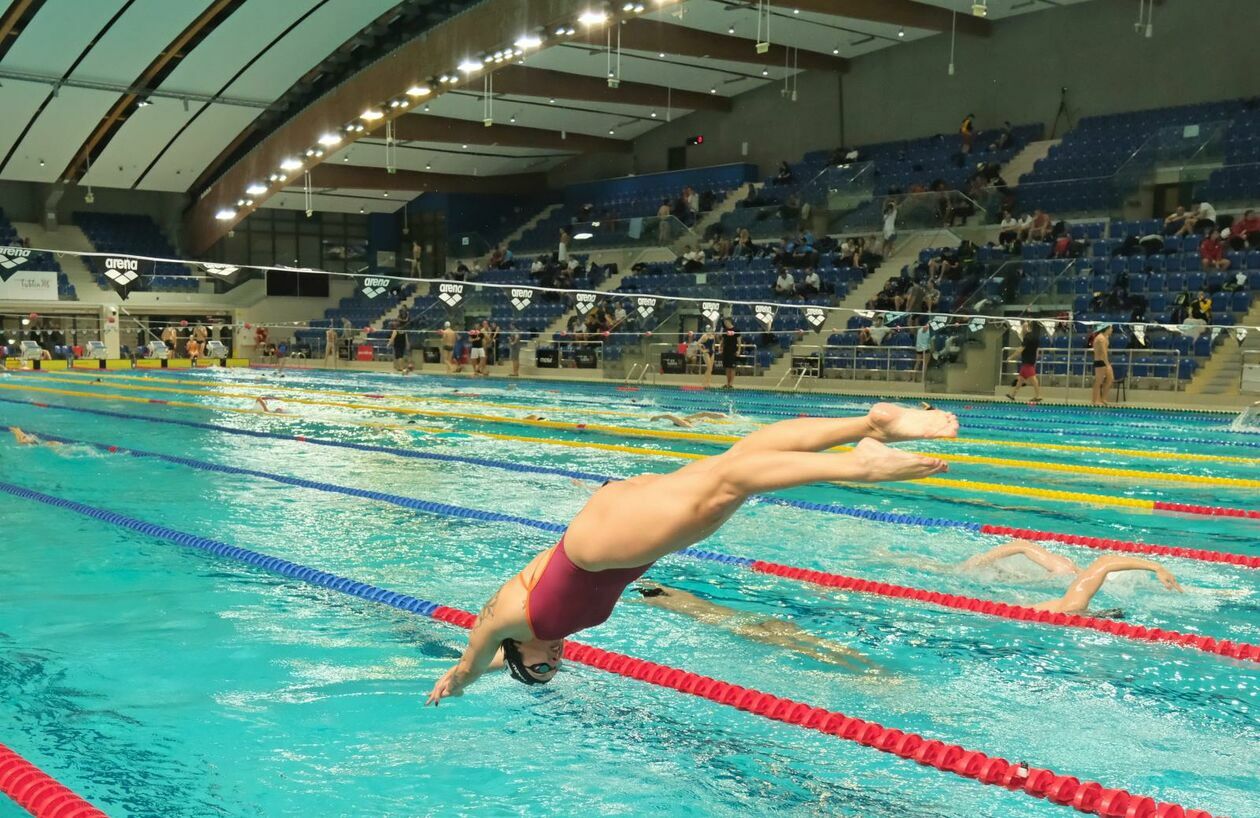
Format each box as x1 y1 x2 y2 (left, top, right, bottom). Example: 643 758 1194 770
0 383 1260 519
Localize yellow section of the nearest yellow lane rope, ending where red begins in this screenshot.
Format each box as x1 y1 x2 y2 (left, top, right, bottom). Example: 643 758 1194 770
0 375 1174 509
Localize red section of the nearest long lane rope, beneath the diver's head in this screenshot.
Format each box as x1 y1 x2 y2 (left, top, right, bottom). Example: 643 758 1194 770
431 605 1213 818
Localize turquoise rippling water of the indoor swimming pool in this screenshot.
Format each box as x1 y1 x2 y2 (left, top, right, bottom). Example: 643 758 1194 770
0 371 1260 818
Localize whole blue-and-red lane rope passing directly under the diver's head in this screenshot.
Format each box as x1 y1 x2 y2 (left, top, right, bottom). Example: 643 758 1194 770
0 483 1213 818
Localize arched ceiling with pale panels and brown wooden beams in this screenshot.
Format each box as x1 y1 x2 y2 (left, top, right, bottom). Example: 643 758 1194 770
0 0 1085 239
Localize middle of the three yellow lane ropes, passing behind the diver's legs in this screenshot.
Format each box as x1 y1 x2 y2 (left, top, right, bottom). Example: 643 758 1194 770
25 376 1260 489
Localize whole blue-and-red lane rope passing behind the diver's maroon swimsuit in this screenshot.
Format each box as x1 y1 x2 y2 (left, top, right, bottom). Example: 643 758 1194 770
19 435 1260 662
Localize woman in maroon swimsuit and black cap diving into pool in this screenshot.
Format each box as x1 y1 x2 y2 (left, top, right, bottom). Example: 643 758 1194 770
426 403 958 705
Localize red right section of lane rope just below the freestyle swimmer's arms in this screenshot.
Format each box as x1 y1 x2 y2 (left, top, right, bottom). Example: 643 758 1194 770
747 560 1260 662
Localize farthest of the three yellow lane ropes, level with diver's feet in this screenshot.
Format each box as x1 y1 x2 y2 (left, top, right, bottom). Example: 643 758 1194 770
50 369 1260 466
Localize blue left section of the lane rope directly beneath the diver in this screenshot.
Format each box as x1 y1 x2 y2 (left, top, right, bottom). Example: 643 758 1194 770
0 483 453 616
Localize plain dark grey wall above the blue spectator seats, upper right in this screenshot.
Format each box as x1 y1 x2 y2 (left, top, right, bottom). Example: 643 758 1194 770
551 0 1260 184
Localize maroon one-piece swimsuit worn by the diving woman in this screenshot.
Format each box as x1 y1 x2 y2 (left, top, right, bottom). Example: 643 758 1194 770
525 537 651 640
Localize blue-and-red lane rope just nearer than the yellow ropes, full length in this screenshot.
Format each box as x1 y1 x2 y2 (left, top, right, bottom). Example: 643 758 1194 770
0 397 1260 568
